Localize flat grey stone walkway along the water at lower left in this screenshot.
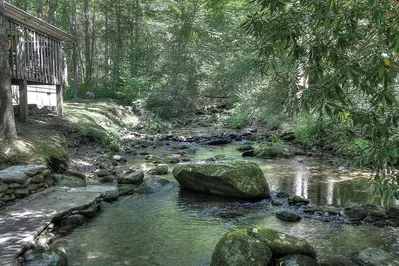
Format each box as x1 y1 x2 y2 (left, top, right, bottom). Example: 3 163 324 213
0 186 117 266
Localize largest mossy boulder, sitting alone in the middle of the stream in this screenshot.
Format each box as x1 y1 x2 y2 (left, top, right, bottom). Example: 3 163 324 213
173 161 270 199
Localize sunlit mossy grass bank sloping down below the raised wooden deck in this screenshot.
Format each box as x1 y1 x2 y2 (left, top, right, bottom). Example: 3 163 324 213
0 100 139 170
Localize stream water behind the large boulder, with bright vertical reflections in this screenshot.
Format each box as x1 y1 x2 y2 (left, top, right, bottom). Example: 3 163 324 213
127 142 373 206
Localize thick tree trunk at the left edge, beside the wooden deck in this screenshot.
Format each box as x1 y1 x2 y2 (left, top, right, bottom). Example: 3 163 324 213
0 0 17 141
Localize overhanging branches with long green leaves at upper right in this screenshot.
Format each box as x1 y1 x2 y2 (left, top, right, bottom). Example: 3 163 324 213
244 0 399 202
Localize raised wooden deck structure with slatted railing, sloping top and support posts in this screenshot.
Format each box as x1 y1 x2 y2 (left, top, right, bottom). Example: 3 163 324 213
4 2 75 122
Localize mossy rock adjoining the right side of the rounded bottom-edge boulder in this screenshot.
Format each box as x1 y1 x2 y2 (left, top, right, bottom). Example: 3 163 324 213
248 227 316 258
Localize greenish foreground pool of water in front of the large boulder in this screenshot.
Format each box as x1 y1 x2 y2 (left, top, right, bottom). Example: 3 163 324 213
66 188 399 266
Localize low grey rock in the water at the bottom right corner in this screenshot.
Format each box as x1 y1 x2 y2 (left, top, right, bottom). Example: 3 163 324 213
351 248 399 266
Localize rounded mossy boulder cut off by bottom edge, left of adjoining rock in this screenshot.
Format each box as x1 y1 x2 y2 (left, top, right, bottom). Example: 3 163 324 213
211 229 272 266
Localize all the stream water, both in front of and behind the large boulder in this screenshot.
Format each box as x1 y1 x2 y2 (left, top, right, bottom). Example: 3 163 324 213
63 141 399 266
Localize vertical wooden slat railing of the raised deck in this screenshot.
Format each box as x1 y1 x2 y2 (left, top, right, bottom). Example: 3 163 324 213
7 21 64 85
